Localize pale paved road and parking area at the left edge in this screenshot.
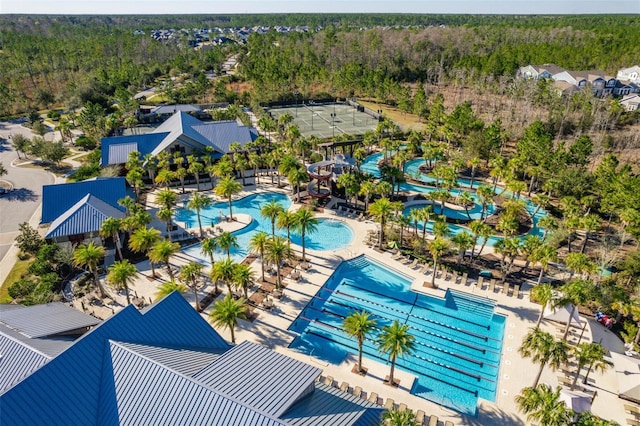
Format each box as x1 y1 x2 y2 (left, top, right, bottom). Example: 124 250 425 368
0 121 55 261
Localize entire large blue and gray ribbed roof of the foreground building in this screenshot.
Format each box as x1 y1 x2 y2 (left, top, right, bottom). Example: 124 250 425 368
0 292 384 426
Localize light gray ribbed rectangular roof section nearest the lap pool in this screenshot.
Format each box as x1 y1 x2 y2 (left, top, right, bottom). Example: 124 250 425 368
193 342 322 417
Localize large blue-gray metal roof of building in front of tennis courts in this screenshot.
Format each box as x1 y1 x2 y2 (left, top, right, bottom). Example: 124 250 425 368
101 111 258 166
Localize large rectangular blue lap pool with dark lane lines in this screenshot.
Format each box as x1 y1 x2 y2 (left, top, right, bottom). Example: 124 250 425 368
290 256 505 415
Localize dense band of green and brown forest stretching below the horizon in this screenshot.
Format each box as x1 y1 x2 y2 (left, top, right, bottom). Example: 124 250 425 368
0 15 640 115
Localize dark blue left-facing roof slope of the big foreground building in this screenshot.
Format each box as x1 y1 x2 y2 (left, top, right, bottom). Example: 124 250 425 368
0 292 228 425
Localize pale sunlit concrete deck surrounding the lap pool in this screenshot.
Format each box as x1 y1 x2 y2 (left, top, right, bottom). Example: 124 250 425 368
82 179 626 426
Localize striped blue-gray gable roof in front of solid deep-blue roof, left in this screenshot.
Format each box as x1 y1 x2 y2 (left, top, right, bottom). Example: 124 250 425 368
45 194 125 238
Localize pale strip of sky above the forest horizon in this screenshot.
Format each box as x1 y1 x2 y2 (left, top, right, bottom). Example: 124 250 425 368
0 0 640 15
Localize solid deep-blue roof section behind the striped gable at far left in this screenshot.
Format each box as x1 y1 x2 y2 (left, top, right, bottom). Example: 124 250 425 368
41 177 127 223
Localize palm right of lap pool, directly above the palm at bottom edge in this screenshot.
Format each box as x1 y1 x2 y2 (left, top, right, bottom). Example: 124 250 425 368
518 328 569 387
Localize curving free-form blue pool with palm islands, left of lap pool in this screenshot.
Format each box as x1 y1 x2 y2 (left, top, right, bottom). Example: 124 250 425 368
175 192 354 264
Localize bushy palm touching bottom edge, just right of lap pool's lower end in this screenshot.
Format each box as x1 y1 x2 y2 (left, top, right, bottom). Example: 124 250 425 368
515 384 571 426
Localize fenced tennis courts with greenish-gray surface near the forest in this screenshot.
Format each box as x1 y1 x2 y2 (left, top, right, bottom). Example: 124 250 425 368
267 103 378 139
